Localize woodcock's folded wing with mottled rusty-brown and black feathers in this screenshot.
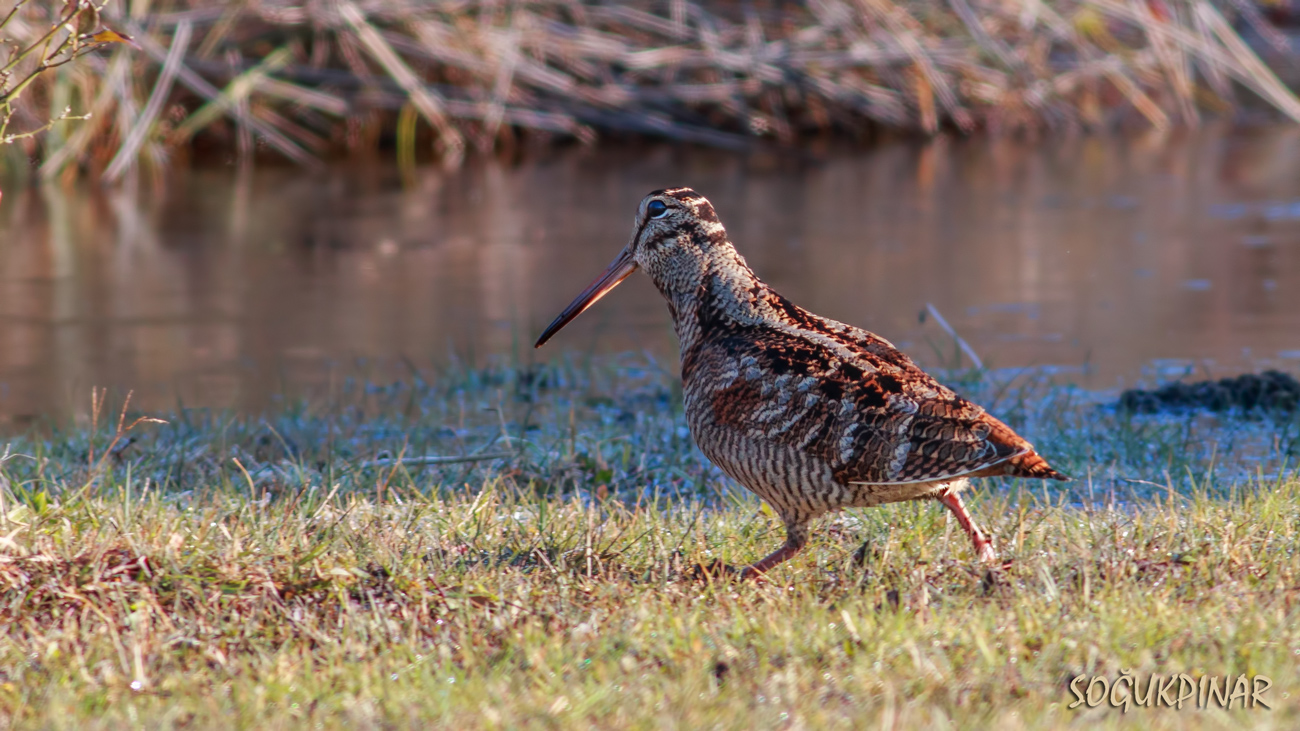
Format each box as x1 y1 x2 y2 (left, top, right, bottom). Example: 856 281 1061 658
696 314 1045 484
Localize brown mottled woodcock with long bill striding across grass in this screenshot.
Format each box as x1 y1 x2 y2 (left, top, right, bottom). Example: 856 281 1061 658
537 187 1069 578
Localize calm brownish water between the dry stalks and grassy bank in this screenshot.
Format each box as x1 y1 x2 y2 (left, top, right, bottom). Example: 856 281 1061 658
0 123 1300 428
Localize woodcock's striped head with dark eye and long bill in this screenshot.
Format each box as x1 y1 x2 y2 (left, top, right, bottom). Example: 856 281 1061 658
534 187 749 347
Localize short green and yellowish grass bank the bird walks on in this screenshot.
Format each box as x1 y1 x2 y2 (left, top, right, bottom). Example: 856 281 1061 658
0 356 1300 728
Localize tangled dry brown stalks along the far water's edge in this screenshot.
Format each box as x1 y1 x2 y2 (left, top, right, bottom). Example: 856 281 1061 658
0 0 1300 181
